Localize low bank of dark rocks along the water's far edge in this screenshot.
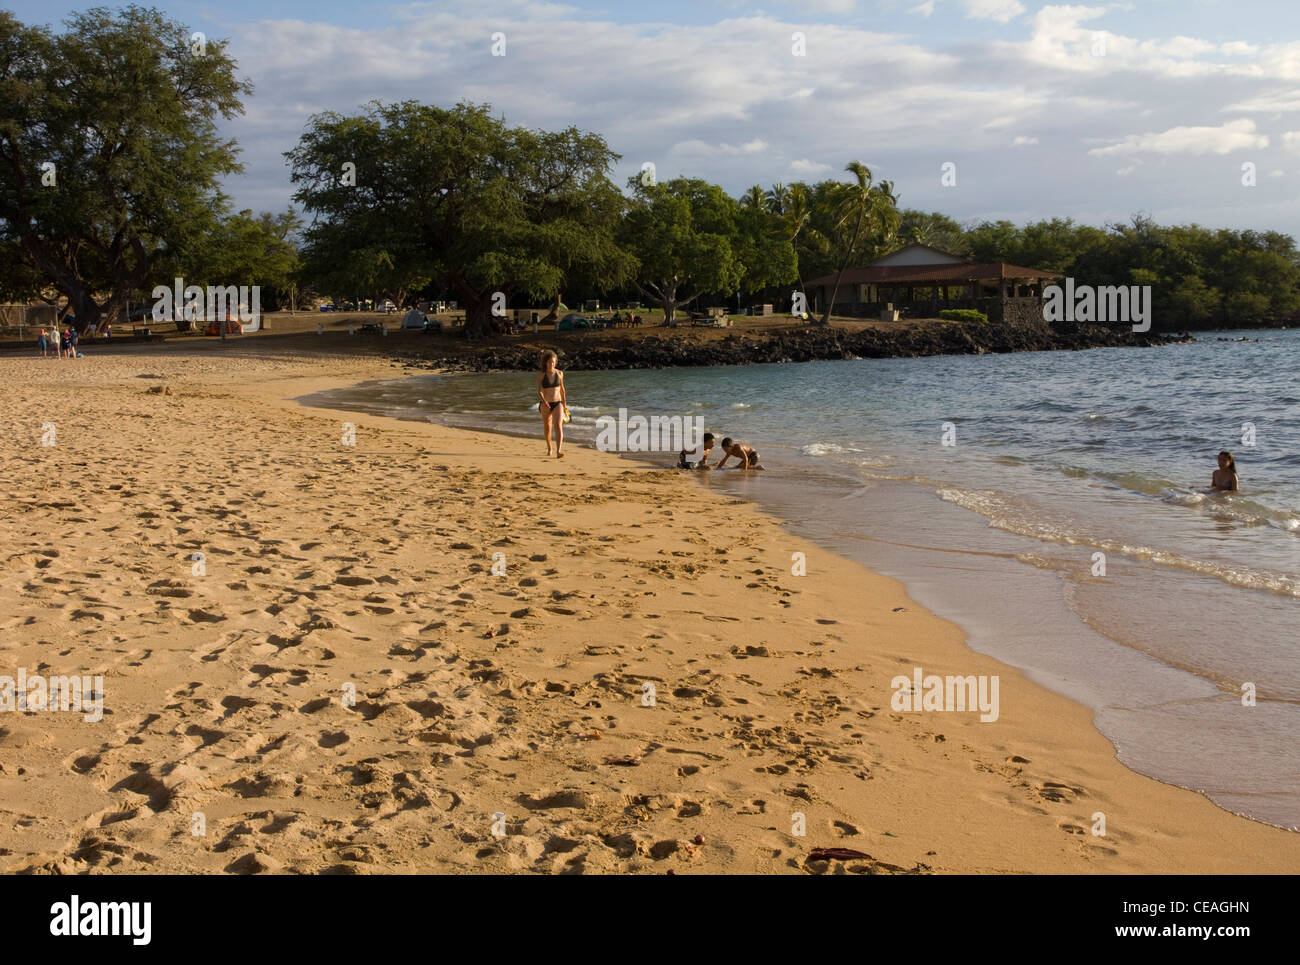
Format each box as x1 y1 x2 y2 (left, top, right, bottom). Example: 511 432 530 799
384 323 1191 372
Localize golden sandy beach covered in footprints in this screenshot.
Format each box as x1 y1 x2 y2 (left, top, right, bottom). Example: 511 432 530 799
0 345 1300 874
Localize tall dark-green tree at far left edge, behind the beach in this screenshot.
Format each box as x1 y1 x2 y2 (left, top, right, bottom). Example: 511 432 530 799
0 7 251 329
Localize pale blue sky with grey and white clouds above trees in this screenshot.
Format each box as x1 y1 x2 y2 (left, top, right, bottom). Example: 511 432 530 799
7 0 1300 237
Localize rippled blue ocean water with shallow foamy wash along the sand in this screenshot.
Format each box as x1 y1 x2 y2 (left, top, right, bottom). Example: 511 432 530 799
312 330 1300 828
